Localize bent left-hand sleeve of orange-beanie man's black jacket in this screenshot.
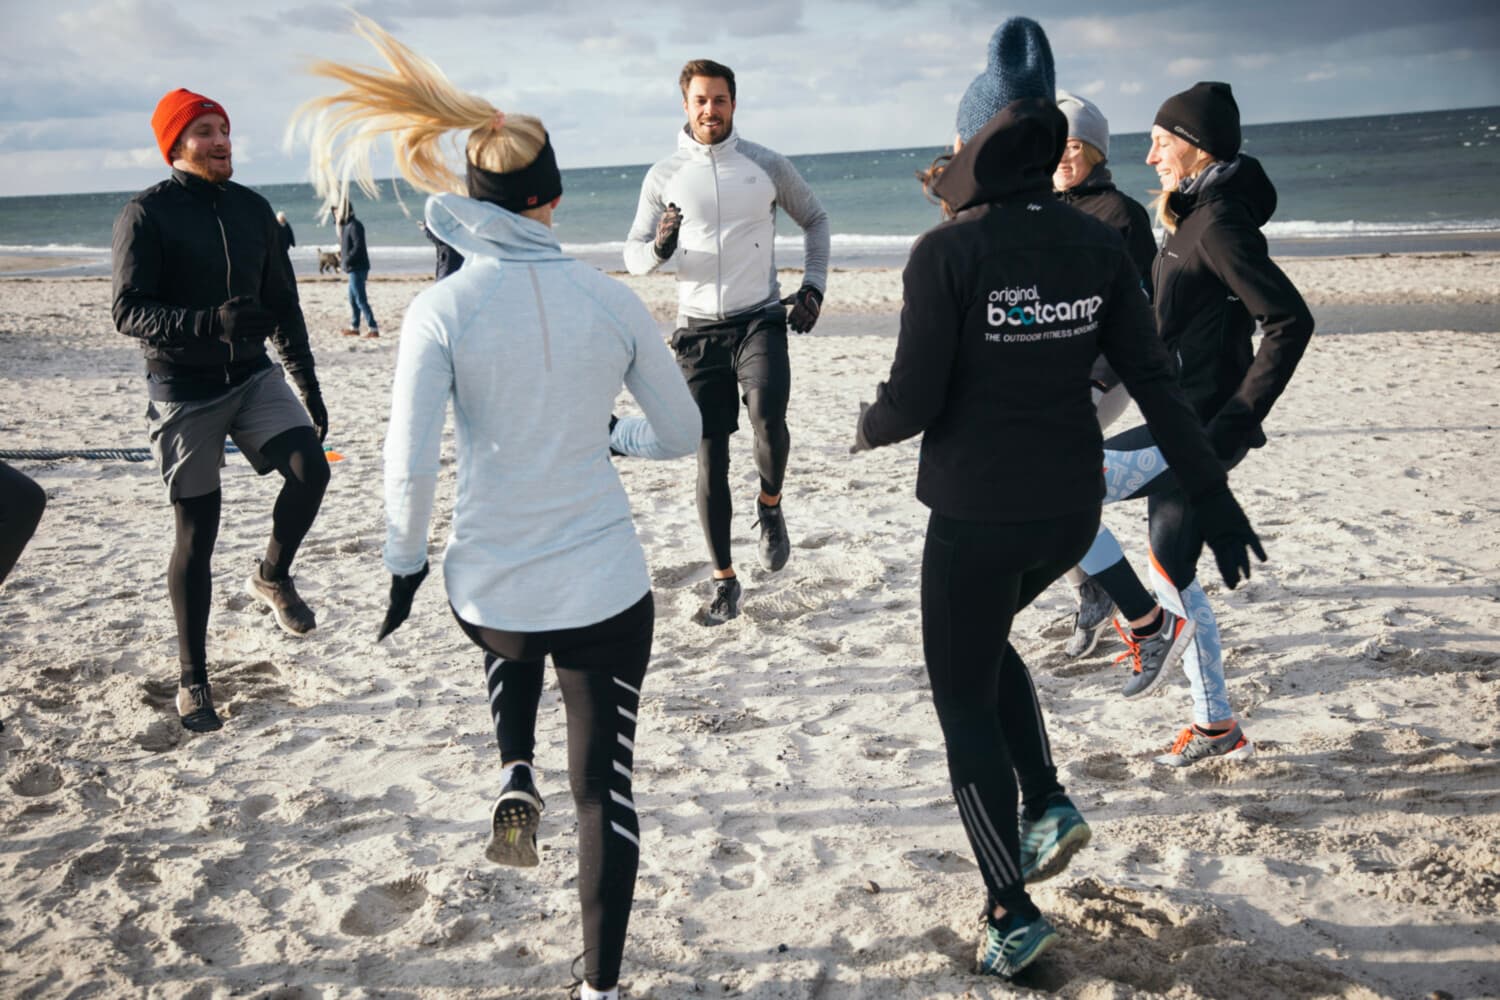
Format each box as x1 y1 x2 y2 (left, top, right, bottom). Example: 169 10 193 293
111 201 215 348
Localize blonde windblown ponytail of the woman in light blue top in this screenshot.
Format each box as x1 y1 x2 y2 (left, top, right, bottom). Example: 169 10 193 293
287 13 548 212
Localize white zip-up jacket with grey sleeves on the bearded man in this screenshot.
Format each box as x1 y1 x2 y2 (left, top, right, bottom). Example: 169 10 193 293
626 126 830 327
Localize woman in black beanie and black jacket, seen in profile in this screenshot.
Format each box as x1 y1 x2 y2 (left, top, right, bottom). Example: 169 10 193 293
1082 82 1313 768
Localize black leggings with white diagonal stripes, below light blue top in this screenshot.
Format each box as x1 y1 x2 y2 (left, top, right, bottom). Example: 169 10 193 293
455 591 656 990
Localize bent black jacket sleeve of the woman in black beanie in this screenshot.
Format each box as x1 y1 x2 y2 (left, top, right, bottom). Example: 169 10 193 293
1202 216 1313 454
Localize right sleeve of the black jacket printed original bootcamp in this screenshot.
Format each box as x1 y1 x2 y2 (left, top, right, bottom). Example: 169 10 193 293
1100 261 1229 499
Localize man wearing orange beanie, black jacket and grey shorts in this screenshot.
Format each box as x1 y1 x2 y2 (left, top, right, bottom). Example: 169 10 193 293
113 90 329 732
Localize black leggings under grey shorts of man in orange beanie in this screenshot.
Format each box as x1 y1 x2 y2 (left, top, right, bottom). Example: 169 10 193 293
167 427 329 687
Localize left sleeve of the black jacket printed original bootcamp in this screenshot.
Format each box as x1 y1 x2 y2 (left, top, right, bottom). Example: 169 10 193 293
860 238 966 447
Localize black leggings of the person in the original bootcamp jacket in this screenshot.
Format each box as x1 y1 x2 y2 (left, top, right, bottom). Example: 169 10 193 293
923 508 1100 913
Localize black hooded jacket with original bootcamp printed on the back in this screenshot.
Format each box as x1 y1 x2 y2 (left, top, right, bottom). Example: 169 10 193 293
860 99 1226 522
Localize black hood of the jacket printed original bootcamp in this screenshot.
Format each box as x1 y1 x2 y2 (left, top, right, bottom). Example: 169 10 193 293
933 97 1068 213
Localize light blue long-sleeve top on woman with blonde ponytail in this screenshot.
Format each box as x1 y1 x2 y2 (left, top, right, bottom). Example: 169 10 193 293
386 195 701 631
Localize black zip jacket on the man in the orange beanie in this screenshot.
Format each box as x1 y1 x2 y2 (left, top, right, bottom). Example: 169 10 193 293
113 169 318 400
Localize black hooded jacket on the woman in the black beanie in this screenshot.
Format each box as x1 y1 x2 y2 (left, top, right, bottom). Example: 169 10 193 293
1152 156 1313 459
